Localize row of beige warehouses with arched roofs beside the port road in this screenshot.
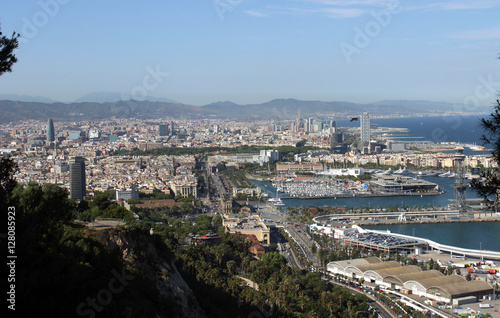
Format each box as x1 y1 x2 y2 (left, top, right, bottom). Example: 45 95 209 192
327 257 494 303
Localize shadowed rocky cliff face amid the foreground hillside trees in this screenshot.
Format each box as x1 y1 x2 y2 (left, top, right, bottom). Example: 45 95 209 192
96 229 205 318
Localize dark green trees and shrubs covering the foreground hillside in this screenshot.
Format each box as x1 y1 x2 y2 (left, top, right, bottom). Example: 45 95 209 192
0 158 376 317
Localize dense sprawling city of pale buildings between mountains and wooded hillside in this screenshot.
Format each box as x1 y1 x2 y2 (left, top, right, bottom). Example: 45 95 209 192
0 110 500 317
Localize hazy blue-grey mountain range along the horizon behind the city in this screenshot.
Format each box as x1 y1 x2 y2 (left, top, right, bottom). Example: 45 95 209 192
0 93 492 123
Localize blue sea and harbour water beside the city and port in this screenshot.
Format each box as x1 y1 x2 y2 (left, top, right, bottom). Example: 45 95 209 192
252 115 500 251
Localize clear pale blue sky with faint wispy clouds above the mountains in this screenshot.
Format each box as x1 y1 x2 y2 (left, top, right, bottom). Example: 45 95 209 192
0 0 500 105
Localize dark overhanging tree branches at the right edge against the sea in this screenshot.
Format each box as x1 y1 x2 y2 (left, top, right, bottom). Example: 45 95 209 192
471 99 500 208
